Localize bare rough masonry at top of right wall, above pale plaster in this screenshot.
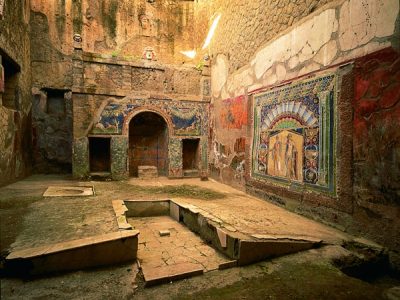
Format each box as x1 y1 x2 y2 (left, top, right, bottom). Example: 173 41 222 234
196 0 332 72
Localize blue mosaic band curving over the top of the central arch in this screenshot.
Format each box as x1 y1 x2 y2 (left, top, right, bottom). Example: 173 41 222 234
91 99 208 136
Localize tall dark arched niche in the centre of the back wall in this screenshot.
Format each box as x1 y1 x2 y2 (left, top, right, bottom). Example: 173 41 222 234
129 112 168 176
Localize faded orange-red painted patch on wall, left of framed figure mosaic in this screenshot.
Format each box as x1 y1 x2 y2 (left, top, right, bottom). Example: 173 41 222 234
220 96 247 129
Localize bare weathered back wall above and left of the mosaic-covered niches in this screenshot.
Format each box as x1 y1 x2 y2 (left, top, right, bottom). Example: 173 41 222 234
30 0 200 172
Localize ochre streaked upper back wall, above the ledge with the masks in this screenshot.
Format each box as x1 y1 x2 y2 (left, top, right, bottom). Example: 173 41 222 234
31 0 193 88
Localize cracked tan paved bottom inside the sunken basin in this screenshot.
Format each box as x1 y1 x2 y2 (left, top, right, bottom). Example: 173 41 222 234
128 216 230 282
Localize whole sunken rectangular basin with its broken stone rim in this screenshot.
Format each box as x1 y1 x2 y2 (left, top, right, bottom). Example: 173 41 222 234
113 200 322 286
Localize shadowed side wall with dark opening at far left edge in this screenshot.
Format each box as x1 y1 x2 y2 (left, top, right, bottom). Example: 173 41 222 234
0 1 31 186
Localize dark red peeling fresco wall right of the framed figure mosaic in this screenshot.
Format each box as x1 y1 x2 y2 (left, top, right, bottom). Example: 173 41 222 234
352 49 400 253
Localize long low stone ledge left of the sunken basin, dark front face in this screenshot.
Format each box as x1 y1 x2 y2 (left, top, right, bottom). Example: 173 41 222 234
5 230 139 276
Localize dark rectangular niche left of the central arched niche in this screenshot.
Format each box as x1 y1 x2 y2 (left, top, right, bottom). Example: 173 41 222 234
89 137 111 173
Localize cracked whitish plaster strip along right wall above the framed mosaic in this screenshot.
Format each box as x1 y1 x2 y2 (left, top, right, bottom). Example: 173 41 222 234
211 0 399 102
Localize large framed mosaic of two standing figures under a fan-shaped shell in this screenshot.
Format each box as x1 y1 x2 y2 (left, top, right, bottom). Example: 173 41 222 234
252 74 335 191
